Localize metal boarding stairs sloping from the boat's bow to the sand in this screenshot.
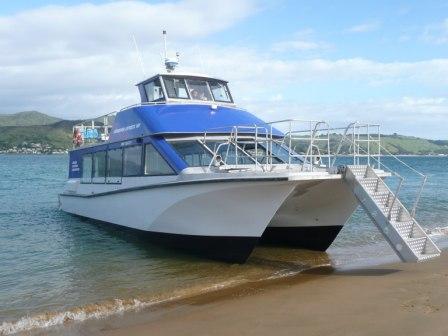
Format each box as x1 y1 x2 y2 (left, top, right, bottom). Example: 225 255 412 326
345 165 440 262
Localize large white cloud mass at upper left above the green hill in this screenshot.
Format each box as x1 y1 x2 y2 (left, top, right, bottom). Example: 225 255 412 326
0 0 256 118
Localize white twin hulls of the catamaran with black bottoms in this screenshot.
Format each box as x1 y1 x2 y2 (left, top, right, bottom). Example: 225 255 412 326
60 179 358 262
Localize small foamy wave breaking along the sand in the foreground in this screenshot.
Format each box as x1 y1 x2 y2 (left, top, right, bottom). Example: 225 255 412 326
0 268 314 336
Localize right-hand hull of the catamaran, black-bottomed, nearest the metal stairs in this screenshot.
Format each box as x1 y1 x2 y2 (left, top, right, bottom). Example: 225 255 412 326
261 180 358 251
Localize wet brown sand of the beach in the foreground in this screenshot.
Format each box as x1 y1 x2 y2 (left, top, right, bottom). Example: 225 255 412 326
53 252 448 336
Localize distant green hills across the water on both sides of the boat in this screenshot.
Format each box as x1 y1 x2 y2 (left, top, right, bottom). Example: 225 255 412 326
0 111 448 155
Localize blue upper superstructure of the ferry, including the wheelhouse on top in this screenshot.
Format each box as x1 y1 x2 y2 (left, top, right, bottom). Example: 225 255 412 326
69 74 283 183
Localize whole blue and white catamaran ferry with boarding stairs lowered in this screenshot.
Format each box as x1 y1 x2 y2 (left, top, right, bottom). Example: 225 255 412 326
59 40 440 262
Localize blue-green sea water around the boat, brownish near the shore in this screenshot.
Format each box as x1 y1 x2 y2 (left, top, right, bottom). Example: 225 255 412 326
0 155 448 335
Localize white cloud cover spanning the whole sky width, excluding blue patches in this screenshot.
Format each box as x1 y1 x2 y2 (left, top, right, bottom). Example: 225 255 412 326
0 0 448 138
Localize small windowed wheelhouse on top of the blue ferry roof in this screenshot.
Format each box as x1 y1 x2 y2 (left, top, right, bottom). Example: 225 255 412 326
137 73 234 105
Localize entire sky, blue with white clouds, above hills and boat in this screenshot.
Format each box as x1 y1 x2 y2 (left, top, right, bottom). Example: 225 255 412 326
0 0 448 139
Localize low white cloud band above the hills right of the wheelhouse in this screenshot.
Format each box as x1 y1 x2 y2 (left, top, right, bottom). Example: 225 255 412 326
242 97 448 139
